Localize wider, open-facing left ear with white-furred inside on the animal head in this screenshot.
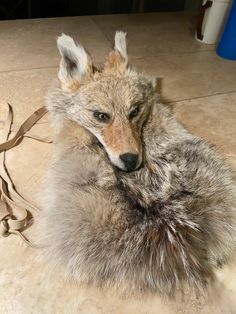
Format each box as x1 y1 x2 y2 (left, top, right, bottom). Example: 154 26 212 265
57 34 93 93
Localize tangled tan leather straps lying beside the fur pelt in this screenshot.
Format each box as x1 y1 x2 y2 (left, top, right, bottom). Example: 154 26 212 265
0 104 51 247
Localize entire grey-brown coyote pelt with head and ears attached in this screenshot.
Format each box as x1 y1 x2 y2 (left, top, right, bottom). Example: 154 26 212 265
41 32 236 295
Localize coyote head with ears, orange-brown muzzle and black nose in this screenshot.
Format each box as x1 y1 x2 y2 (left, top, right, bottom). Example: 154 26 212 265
49 32 157 171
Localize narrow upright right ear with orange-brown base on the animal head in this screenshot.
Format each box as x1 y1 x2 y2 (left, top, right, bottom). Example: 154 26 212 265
104 31 128 74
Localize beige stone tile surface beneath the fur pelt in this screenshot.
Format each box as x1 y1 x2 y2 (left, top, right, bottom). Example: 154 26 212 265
0 13 236 314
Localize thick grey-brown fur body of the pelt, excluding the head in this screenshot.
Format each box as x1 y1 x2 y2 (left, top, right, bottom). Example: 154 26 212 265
41 32 236 295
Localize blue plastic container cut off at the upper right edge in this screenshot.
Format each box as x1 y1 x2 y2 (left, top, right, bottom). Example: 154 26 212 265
216 0 236 60
